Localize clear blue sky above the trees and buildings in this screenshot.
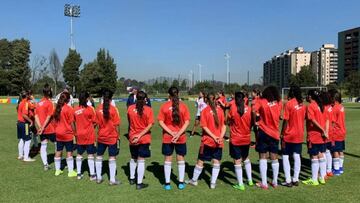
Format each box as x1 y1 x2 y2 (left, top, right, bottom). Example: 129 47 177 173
0 0 360 83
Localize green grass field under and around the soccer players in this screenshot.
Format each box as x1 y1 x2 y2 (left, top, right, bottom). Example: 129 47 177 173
0 102 360 202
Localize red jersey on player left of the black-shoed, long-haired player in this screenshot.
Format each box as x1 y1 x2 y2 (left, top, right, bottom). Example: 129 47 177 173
96 104 120 145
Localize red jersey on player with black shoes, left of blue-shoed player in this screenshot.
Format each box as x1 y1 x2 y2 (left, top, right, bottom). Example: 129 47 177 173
127 104 154 145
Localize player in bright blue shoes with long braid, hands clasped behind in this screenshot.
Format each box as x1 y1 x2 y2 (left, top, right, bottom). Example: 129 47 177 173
158 87 190 190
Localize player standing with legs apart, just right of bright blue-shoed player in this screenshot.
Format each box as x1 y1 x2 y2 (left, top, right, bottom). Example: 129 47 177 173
187 93 226 189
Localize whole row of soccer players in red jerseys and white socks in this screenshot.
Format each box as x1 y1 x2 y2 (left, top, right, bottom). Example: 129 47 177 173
17 85 346 190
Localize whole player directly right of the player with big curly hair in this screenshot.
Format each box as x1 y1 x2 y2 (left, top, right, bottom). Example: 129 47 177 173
281 86 306 187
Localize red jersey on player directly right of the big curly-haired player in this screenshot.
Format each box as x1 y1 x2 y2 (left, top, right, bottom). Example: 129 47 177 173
283 98 306 143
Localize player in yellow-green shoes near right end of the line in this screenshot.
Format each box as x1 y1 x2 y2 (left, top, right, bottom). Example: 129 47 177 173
302 90 329 186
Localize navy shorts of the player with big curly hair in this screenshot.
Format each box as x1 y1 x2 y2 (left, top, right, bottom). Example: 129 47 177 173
255 129 279 154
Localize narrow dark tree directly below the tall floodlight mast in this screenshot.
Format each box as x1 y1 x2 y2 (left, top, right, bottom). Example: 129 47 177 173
62 49 82 93
